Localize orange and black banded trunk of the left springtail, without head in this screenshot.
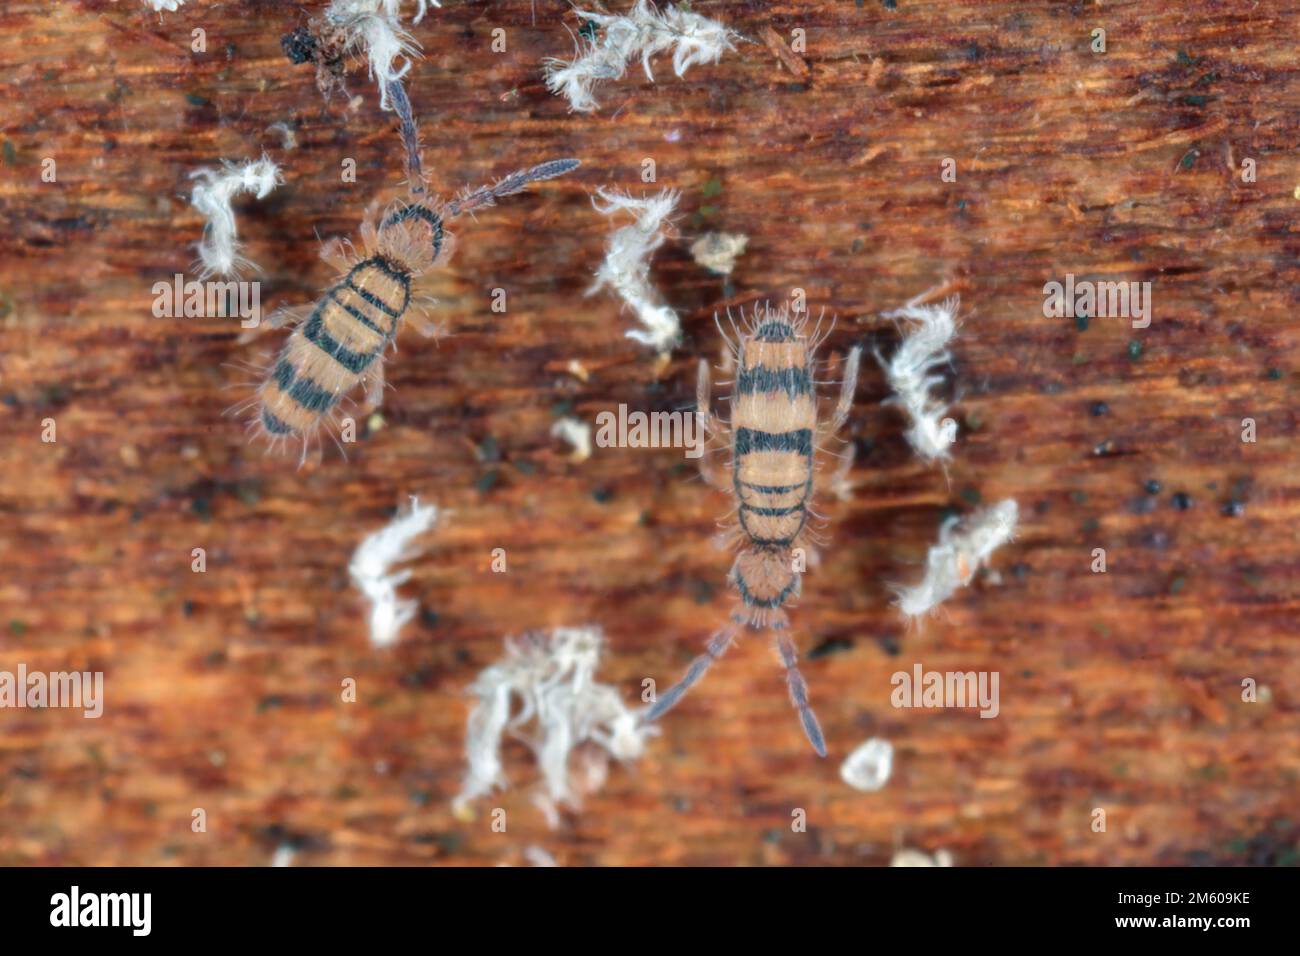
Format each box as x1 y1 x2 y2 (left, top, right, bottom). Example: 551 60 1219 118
259 255 411 437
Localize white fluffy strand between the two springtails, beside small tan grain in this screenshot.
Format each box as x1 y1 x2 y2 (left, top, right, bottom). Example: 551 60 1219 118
588 190 681 352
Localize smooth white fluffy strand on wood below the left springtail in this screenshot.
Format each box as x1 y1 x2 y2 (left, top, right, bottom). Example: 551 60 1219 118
347 497 438 648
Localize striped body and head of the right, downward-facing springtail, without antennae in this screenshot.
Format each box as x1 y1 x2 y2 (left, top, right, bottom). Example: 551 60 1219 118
732 316 816 609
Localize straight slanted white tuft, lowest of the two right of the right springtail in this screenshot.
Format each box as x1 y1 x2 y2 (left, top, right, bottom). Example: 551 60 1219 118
894 498 1019 618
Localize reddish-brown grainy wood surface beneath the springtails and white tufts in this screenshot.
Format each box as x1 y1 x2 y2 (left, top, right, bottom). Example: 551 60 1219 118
0 0 1300 865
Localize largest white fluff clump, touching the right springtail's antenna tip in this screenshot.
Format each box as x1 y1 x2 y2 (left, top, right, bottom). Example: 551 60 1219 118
452 627 659 826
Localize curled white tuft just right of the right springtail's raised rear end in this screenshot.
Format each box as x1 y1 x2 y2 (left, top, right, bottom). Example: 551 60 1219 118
878 298 958 464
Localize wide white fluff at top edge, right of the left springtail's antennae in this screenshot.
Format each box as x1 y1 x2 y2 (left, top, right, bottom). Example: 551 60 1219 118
543 0 740 113
